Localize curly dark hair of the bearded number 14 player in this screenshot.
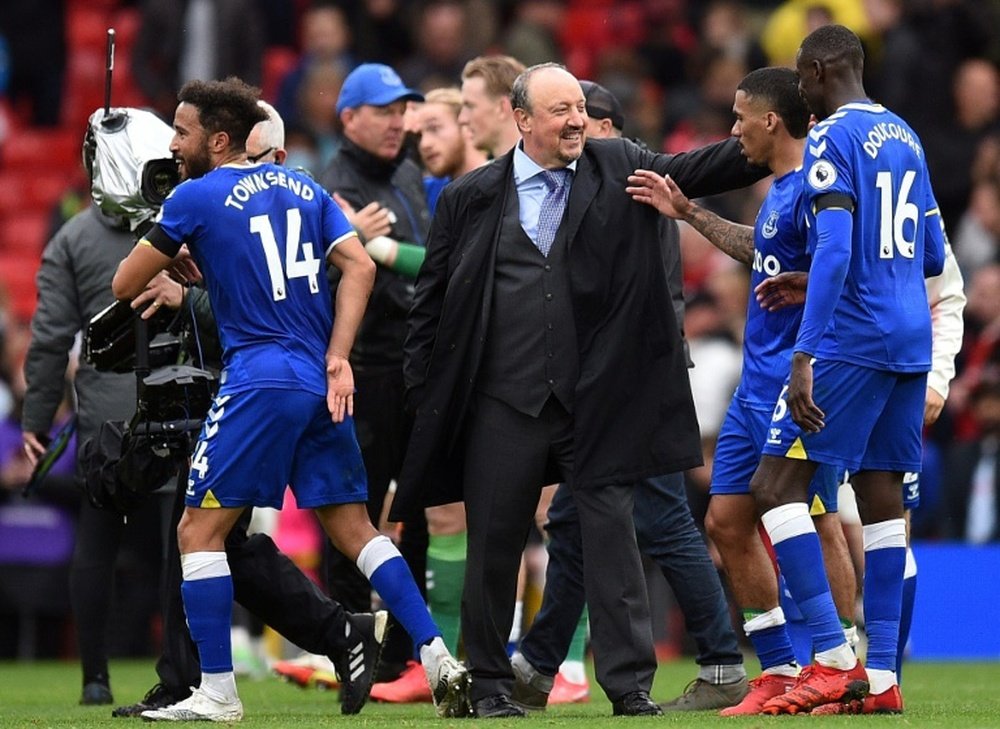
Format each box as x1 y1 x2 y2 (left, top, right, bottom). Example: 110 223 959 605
177 76 268 151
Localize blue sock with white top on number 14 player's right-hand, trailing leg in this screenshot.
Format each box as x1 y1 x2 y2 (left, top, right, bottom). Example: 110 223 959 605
358 535 441 649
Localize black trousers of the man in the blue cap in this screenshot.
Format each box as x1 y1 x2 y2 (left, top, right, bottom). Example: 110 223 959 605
325 368 428 675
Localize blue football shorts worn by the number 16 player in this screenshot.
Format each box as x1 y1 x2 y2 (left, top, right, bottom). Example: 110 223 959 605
763 360 927 473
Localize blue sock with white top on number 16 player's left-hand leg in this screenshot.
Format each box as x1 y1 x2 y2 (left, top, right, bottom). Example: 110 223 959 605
761 502 846 653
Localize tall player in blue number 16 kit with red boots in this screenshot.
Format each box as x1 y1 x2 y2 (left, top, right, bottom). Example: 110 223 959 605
751 25 944 714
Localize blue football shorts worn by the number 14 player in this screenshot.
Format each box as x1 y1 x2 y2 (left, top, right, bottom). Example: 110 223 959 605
185 388 368 509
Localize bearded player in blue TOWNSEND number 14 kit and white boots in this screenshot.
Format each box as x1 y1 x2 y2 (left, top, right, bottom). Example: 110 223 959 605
112 78 469 721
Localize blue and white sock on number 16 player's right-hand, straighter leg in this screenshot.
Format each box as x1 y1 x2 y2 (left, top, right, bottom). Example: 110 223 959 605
863 519 906 671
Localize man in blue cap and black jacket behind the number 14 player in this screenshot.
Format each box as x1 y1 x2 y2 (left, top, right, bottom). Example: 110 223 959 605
321 63 430 680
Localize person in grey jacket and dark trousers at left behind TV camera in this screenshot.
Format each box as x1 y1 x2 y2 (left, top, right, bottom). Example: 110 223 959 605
21 136 169 704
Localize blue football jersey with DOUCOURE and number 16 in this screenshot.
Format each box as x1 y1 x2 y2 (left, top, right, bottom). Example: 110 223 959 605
799 102 943 372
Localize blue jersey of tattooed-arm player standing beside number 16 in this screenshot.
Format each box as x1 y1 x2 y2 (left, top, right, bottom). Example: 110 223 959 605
736 169 809 409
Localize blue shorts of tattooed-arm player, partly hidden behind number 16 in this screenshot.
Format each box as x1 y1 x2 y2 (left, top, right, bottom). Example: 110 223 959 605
709 397 843 516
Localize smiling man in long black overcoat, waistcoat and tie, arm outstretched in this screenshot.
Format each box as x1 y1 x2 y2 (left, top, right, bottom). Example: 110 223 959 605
392 64 764 717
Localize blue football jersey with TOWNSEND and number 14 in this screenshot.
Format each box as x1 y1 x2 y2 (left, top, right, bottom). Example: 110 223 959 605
157 164 355 395
